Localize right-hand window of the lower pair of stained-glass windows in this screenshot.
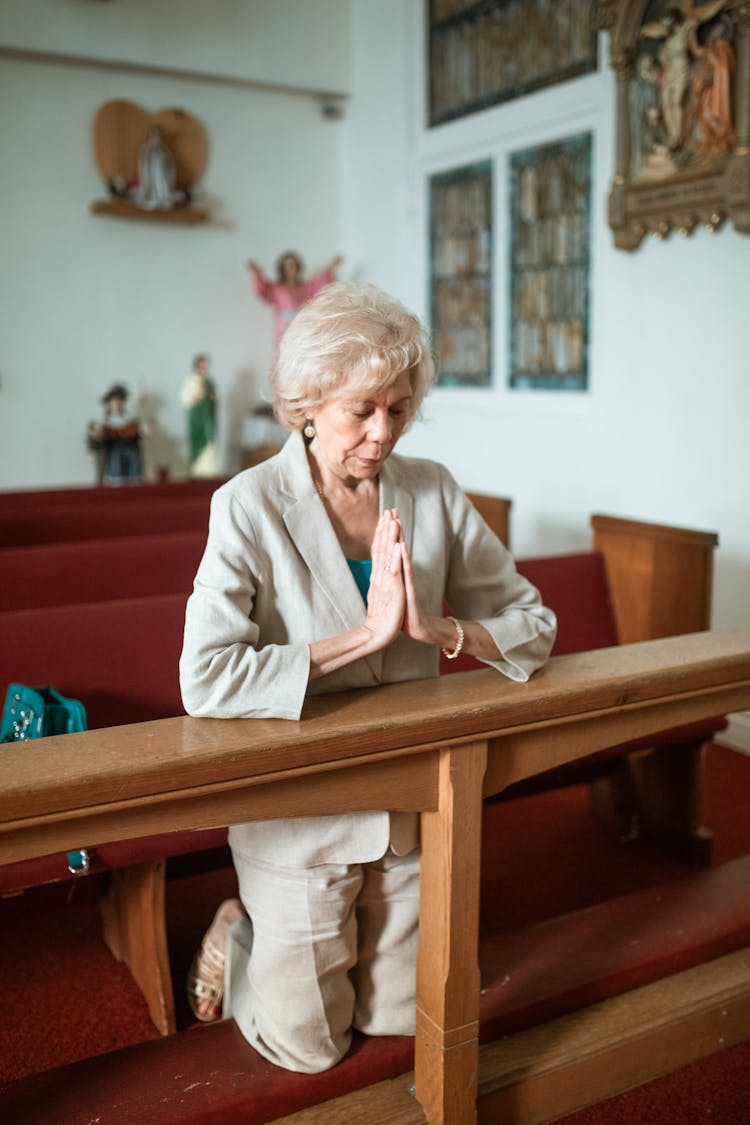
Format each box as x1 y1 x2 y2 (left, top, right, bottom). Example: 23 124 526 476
508 133 591 390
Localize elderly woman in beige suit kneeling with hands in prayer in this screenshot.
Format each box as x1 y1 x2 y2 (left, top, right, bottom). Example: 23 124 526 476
180 284 555 1072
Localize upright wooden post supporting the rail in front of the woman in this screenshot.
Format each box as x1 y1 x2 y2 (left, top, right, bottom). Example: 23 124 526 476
415 741 487 1125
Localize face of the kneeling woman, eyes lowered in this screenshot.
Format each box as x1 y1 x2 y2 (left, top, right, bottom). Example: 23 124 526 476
311 371 412 480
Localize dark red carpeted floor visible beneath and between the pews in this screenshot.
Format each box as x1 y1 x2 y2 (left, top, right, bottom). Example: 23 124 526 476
0 746 750 1125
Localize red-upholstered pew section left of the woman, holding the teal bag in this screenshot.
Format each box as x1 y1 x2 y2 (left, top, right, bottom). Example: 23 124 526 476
0 589 226 1034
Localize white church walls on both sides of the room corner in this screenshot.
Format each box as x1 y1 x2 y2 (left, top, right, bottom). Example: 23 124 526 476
0 0 750 643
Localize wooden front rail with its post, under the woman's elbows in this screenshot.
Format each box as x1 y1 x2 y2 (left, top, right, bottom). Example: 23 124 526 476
0 629 750 1125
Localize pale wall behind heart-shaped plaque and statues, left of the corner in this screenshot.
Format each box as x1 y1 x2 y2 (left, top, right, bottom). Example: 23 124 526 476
0 0 349 488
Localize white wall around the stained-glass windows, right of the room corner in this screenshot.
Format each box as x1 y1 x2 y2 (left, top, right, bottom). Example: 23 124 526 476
343 0 750 628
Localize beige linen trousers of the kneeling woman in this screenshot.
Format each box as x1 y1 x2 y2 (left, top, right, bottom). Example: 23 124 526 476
224 849 419 1073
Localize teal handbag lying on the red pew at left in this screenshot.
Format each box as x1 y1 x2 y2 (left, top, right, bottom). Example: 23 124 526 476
0 684 89 875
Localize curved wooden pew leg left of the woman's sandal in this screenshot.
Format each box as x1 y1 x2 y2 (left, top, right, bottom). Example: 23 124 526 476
99 860 175 1035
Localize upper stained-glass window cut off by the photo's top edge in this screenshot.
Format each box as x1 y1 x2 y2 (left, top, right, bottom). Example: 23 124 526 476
426 0 597 125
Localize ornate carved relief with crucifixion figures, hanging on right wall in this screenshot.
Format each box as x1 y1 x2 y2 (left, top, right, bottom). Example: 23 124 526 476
598 0 750 250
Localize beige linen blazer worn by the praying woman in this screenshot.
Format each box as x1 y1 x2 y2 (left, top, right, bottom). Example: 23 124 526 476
180 433 555 866
